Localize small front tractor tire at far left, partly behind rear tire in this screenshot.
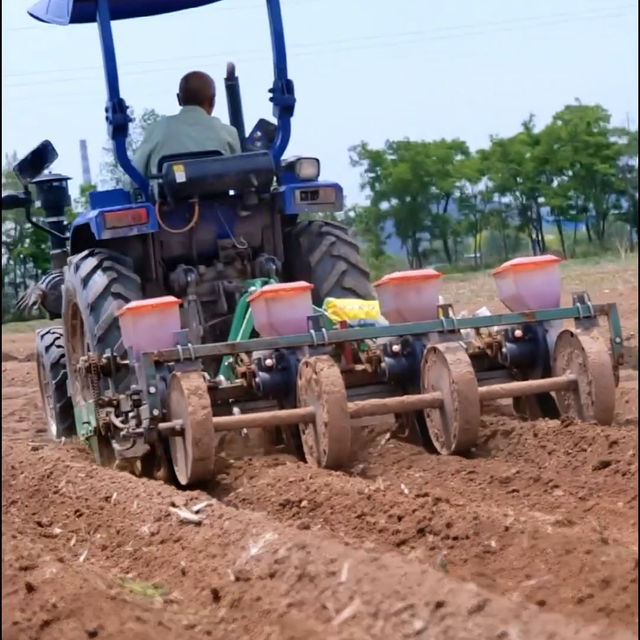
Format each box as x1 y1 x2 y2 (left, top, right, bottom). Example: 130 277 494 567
36 327 76 440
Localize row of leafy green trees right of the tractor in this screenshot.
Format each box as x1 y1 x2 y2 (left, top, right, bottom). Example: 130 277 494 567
349 101 638 269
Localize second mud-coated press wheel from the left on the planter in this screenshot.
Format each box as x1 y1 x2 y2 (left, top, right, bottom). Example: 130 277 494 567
298 356 351 469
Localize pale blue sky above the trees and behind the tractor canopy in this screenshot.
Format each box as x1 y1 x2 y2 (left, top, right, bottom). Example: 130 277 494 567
2 0 638 203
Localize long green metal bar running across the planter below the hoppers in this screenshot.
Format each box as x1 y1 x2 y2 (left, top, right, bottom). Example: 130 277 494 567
144 303 624 365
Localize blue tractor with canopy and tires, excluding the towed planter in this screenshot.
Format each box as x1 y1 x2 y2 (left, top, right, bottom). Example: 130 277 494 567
3 0 375 476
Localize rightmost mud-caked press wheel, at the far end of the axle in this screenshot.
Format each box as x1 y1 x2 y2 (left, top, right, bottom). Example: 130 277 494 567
552 329 616 425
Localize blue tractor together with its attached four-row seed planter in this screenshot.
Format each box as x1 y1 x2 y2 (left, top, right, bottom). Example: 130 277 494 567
2 0 623 486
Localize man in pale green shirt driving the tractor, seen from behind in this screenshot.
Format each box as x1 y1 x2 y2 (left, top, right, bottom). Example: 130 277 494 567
133 71 241 176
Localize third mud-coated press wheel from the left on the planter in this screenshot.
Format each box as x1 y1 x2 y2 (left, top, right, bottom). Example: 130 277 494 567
421 343 480 455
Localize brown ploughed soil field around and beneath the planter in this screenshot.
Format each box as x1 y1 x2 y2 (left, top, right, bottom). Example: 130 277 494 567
2 261 638 640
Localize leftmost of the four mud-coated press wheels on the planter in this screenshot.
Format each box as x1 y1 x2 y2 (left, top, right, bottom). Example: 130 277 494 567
167 371 215 487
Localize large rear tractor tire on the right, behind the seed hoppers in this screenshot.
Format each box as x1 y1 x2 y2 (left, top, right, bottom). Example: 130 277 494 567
284 220 377 307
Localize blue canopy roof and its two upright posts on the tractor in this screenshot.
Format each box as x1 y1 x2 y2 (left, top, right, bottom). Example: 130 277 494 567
28 0 296 199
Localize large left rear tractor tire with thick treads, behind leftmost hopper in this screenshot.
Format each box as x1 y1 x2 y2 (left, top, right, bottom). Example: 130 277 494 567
63 249 142 466
